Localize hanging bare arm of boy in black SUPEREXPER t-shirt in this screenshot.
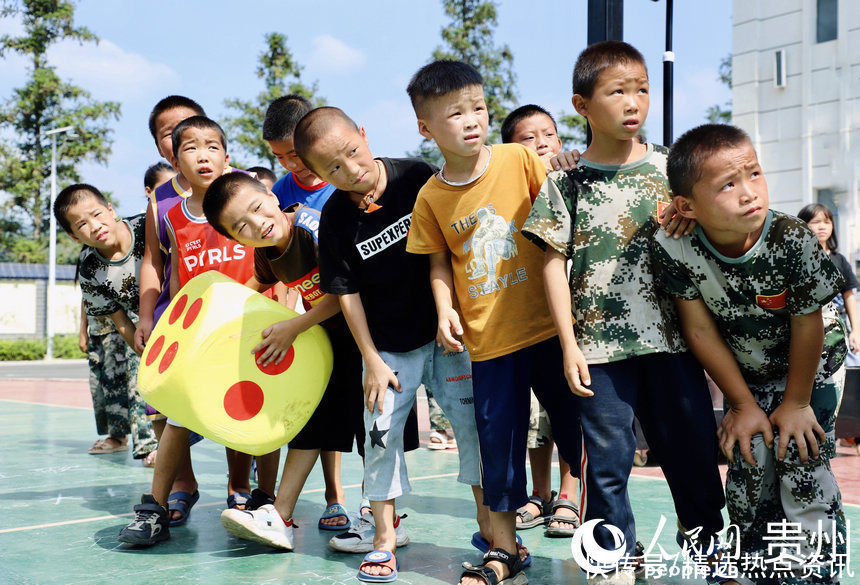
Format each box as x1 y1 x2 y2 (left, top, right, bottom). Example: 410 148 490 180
340 293 400 413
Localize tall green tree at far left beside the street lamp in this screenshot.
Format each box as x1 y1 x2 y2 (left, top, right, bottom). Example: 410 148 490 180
0 0 120 251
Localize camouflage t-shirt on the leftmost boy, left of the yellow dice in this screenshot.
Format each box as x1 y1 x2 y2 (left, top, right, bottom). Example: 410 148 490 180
80 214 146 321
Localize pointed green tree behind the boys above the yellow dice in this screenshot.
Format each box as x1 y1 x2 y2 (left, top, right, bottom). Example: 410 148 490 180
224 33 325 169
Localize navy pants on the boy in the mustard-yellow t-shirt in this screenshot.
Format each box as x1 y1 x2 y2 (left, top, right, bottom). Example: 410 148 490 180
472 337 584 512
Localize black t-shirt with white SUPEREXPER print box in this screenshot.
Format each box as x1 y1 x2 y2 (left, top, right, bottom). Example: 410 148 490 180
319 158 437 352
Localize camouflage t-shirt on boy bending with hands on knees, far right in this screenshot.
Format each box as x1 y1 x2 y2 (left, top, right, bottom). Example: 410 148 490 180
652 210 847 384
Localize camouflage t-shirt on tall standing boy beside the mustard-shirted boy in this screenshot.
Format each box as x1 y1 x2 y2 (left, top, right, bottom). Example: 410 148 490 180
523 144 685 364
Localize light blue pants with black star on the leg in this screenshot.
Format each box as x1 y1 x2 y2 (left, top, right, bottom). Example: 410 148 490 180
364 341 484 502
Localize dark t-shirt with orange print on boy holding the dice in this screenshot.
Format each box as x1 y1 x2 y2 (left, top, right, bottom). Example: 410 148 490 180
254 203 345 330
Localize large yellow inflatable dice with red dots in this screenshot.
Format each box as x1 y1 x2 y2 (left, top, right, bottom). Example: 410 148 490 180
138 271 332 455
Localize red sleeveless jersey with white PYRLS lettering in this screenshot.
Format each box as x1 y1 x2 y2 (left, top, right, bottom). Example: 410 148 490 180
165 199 254 287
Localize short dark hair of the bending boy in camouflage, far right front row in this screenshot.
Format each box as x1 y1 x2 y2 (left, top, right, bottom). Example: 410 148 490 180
666 124 752 198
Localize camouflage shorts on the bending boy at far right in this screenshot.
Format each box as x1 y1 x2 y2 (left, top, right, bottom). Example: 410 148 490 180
726 368 846 584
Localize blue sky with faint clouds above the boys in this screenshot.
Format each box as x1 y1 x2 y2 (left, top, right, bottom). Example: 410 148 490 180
0 0 732 214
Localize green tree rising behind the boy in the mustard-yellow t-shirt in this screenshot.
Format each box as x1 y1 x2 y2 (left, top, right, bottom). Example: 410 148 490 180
411 0 517 165
